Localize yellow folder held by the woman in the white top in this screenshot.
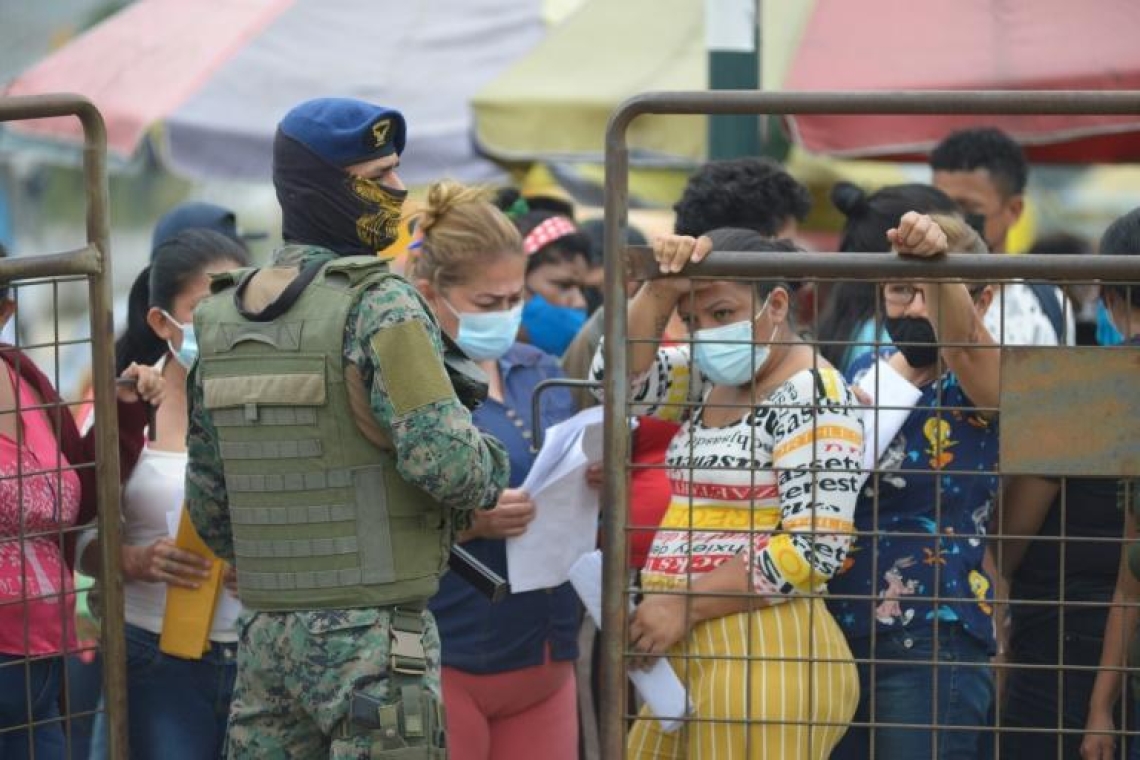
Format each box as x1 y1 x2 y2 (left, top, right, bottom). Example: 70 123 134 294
158 509 226 660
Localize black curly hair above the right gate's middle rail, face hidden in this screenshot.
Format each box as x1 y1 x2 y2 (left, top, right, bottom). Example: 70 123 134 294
673 158 812 237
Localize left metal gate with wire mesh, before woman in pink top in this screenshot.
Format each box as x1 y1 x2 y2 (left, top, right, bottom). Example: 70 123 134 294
0 96 127 758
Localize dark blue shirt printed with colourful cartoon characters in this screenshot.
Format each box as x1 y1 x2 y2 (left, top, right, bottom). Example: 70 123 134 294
828 354 998 651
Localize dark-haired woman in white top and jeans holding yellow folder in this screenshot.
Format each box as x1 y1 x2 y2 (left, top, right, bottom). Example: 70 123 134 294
79 229 250 760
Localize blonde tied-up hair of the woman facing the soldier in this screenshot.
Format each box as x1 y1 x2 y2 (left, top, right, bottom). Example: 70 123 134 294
410 180 523 289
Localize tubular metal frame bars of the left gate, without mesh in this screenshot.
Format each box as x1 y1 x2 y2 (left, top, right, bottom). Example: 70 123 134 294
0 95 127 760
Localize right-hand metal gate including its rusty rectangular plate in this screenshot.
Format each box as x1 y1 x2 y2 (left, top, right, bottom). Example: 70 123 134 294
600 91 1140 760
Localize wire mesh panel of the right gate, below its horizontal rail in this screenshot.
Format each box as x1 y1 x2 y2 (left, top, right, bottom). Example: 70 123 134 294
601 263 1140 758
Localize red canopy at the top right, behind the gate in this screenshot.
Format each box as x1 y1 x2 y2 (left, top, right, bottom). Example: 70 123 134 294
784 0 1140 163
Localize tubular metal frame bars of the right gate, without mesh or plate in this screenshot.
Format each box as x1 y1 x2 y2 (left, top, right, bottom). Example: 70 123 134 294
600 90 1140 760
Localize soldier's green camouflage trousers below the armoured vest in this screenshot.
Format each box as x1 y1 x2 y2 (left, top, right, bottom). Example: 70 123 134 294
227 607 447 760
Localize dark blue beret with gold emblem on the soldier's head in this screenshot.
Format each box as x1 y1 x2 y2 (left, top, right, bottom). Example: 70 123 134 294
279 98 407 166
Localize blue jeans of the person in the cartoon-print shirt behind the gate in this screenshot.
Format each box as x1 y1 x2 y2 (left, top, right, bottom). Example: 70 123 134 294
831 623 994 760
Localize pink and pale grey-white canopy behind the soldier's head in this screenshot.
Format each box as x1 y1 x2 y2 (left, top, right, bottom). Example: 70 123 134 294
7 0 545 185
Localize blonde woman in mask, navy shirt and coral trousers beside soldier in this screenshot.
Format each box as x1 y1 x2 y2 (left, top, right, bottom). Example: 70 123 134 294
408 182 579 760
